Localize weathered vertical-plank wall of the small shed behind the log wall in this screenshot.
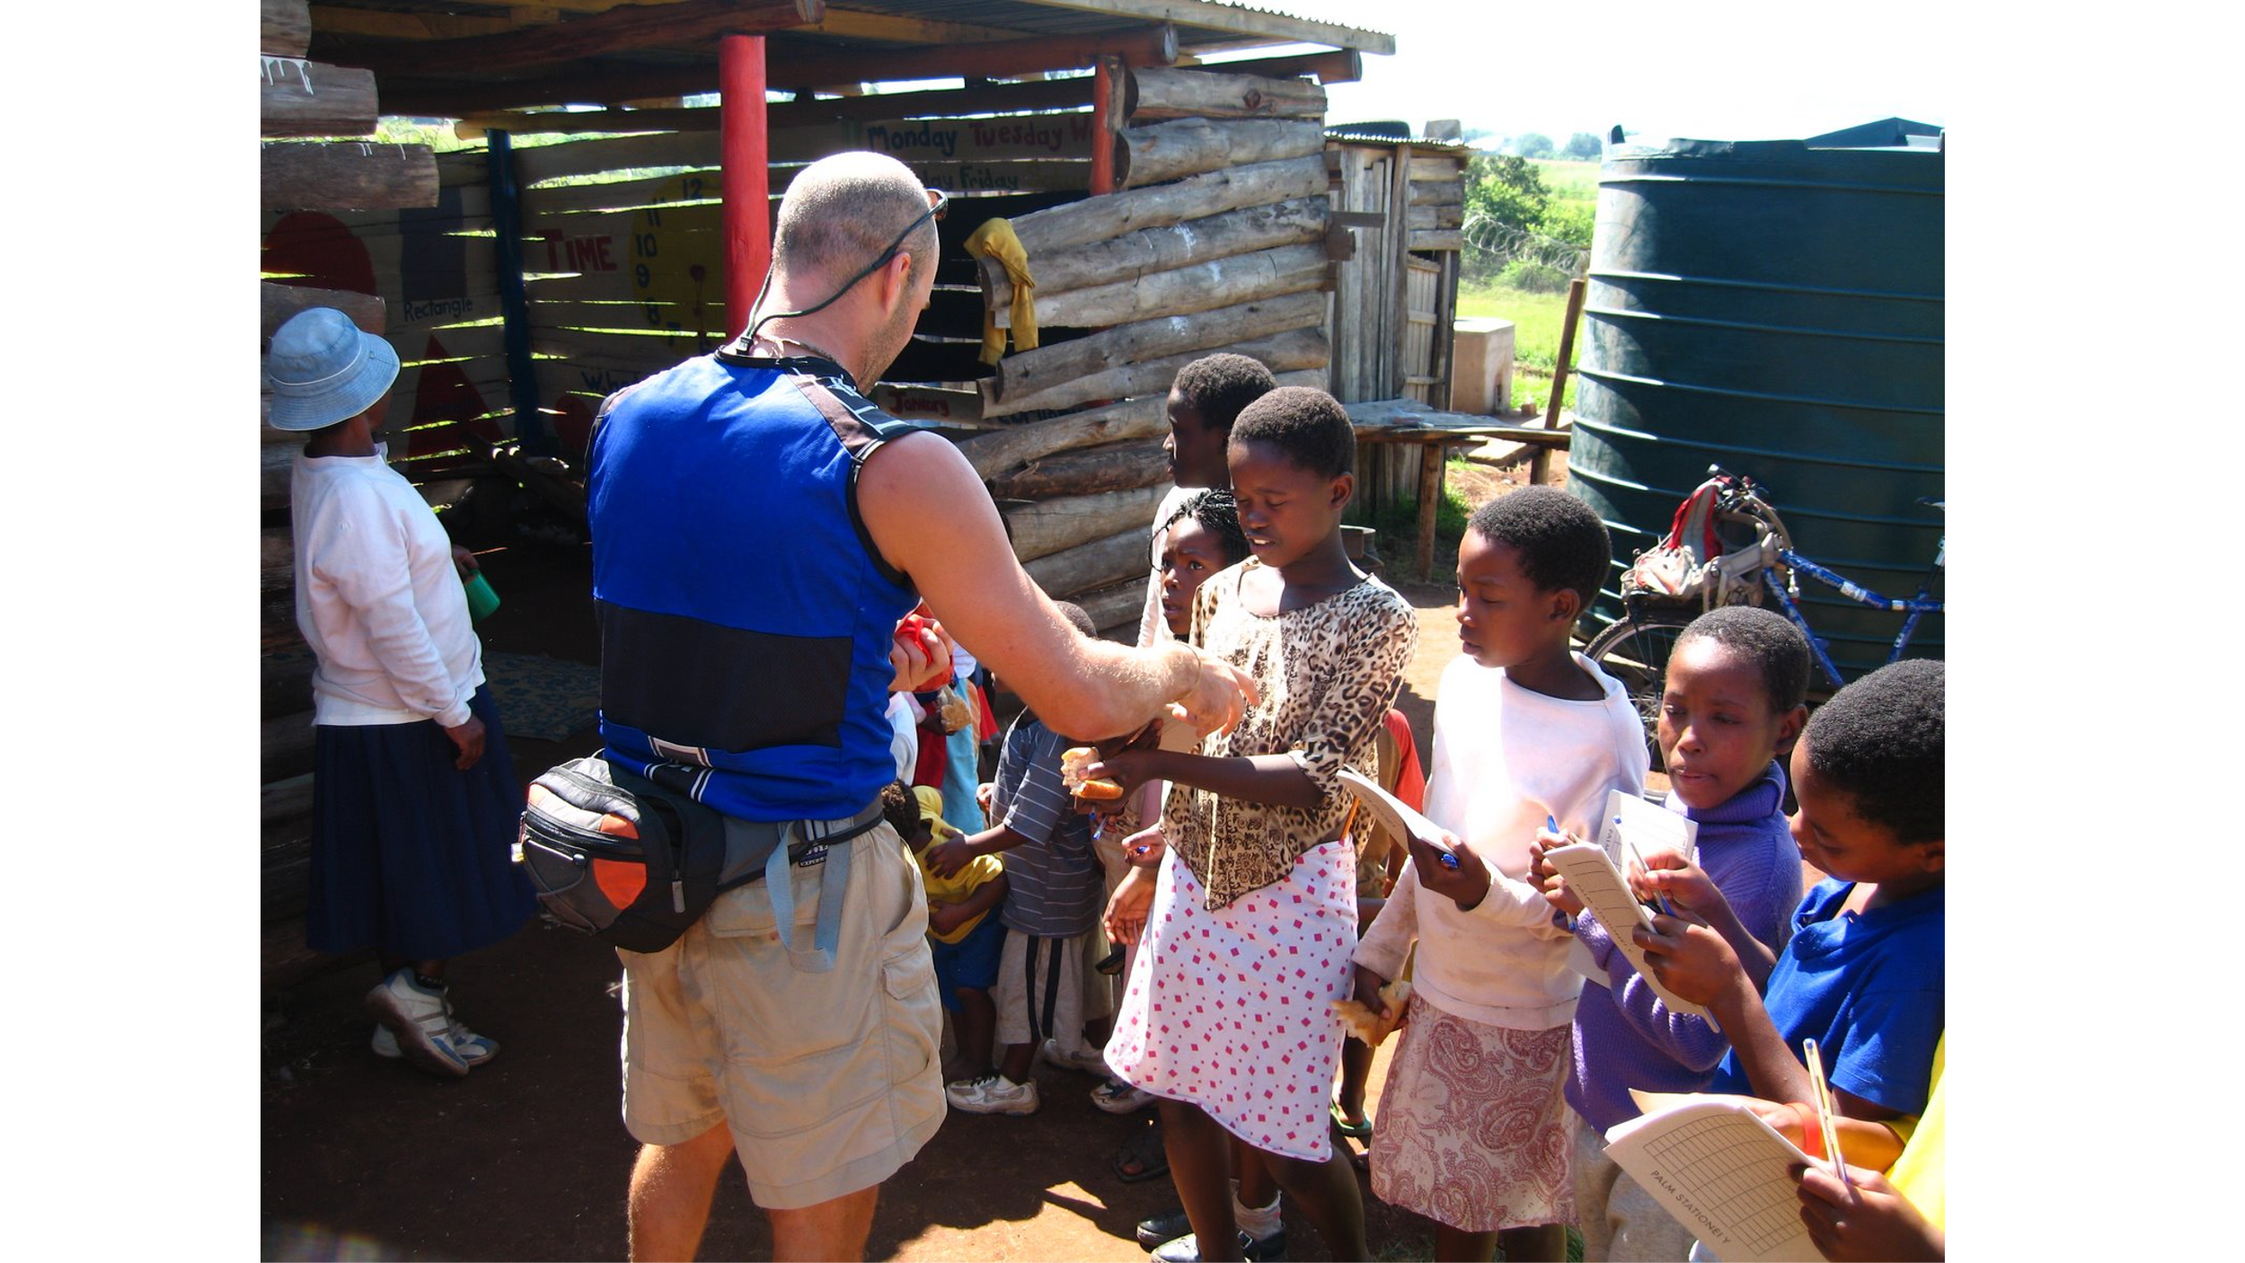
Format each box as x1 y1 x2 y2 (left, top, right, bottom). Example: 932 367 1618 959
1327 141 1466 531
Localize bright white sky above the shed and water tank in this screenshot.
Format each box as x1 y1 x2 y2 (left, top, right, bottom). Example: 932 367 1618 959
1230 0 1955 146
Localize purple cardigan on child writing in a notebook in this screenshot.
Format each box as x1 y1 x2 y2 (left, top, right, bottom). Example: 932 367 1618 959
1567 763 1800 1133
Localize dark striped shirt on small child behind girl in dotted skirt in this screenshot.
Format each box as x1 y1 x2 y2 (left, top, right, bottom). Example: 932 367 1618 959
992 711 1107 938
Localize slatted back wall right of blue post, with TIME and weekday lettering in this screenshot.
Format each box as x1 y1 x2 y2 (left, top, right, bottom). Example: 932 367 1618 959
493 95 1122 455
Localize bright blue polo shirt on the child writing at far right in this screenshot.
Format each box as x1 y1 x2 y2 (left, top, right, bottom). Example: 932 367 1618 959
1708 877 1946 1115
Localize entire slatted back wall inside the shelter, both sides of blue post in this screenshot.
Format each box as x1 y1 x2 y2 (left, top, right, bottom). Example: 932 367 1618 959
263 79 1104 482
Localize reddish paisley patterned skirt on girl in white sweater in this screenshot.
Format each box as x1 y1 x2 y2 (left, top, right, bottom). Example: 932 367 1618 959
1372 996 1574 1232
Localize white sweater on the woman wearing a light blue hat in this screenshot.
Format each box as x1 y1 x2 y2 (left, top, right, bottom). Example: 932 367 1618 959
290 446 483 727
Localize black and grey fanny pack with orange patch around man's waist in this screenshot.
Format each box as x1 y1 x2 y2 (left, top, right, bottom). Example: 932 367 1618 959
514 754 880 955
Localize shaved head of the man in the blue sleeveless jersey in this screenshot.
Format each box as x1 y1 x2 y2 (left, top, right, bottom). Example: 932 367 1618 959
772 153 936 283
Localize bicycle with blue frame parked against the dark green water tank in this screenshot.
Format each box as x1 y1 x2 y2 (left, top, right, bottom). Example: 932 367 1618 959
1583 464 1949 772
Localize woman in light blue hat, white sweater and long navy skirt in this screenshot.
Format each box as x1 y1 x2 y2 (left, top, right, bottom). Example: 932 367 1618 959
265 307 537 1077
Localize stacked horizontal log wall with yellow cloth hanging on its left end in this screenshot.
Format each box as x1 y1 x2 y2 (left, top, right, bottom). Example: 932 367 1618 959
961 67 1347 630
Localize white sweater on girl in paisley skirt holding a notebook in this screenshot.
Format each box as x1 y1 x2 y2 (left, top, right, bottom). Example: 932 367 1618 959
1356 655 1650 1030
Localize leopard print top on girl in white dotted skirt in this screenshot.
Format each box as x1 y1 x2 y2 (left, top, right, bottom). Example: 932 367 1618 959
1163 556 1419 911
